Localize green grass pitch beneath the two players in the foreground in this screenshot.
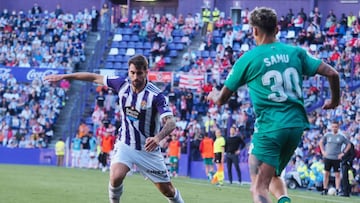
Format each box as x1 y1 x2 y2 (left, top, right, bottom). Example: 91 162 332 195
0 164 360 203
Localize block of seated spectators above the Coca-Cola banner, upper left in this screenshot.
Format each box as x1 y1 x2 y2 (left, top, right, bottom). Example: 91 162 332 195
0 4 91 72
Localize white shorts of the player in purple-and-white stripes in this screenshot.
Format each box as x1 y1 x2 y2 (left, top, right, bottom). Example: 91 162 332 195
111 142 170 183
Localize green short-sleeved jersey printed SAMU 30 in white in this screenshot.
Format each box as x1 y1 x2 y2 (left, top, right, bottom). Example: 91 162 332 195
225 42 321 132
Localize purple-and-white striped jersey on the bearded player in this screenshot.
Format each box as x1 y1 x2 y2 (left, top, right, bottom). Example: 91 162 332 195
104 76 173 150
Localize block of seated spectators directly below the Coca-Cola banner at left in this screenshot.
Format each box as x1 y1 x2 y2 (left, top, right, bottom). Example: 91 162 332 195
0 75 68 148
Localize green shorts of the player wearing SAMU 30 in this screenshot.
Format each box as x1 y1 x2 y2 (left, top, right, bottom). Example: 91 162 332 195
249 127 304 176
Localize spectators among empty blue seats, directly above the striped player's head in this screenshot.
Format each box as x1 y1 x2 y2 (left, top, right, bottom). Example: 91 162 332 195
110 7 199 71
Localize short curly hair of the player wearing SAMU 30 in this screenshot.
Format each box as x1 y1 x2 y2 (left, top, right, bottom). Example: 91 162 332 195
250 7 277 34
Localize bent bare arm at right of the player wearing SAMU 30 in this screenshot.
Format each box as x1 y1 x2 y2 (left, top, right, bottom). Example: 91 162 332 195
317 62 340 109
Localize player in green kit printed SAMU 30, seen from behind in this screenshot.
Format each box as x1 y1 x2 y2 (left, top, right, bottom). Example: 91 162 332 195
208 7 340 203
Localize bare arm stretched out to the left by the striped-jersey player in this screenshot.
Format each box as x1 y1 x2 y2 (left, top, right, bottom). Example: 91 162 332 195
44 72 104 85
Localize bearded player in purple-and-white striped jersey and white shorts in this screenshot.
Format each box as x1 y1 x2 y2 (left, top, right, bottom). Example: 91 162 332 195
44 55 184 203
